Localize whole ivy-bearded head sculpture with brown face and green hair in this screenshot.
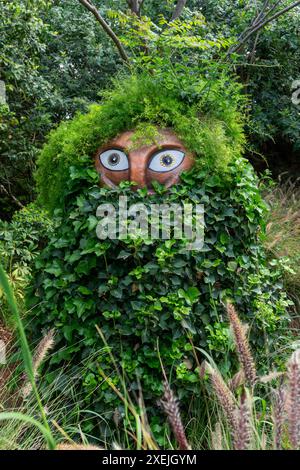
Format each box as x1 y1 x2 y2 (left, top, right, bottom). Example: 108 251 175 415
28 84 286 438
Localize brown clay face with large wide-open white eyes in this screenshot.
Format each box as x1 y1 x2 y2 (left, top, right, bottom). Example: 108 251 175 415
95 129 194 192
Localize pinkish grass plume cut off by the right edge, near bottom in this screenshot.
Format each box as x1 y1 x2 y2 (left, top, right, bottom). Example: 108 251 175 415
286 350 300 450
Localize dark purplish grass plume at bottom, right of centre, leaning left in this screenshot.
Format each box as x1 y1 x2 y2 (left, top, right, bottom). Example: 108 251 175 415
161 381 190 450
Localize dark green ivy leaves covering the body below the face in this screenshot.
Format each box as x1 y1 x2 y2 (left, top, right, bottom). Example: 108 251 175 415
29 156 288 424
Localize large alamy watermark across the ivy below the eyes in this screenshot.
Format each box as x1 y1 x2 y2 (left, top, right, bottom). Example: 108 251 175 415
96 196 204 250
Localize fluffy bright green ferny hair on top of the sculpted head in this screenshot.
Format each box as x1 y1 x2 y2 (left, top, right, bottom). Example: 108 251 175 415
36 76 244 212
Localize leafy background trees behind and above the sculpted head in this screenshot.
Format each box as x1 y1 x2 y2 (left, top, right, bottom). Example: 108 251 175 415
0 0 299 219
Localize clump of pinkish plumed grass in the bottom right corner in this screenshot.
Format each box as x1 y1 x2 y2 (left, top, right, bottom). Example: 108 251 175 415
199 304 300 450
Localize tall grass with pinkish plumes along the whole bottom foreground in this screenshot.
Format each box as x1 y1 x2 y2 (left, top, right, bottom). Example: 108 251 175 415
0 266 300 450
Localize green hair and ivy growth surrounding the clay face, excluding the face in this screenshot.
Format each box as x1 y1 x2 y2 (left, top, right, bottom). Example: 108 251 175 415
29 77 288 434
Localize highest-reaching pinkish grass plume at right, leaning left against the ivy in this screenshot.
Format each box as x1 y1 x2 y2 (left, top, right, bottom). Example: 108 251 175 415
226 302 257 388
